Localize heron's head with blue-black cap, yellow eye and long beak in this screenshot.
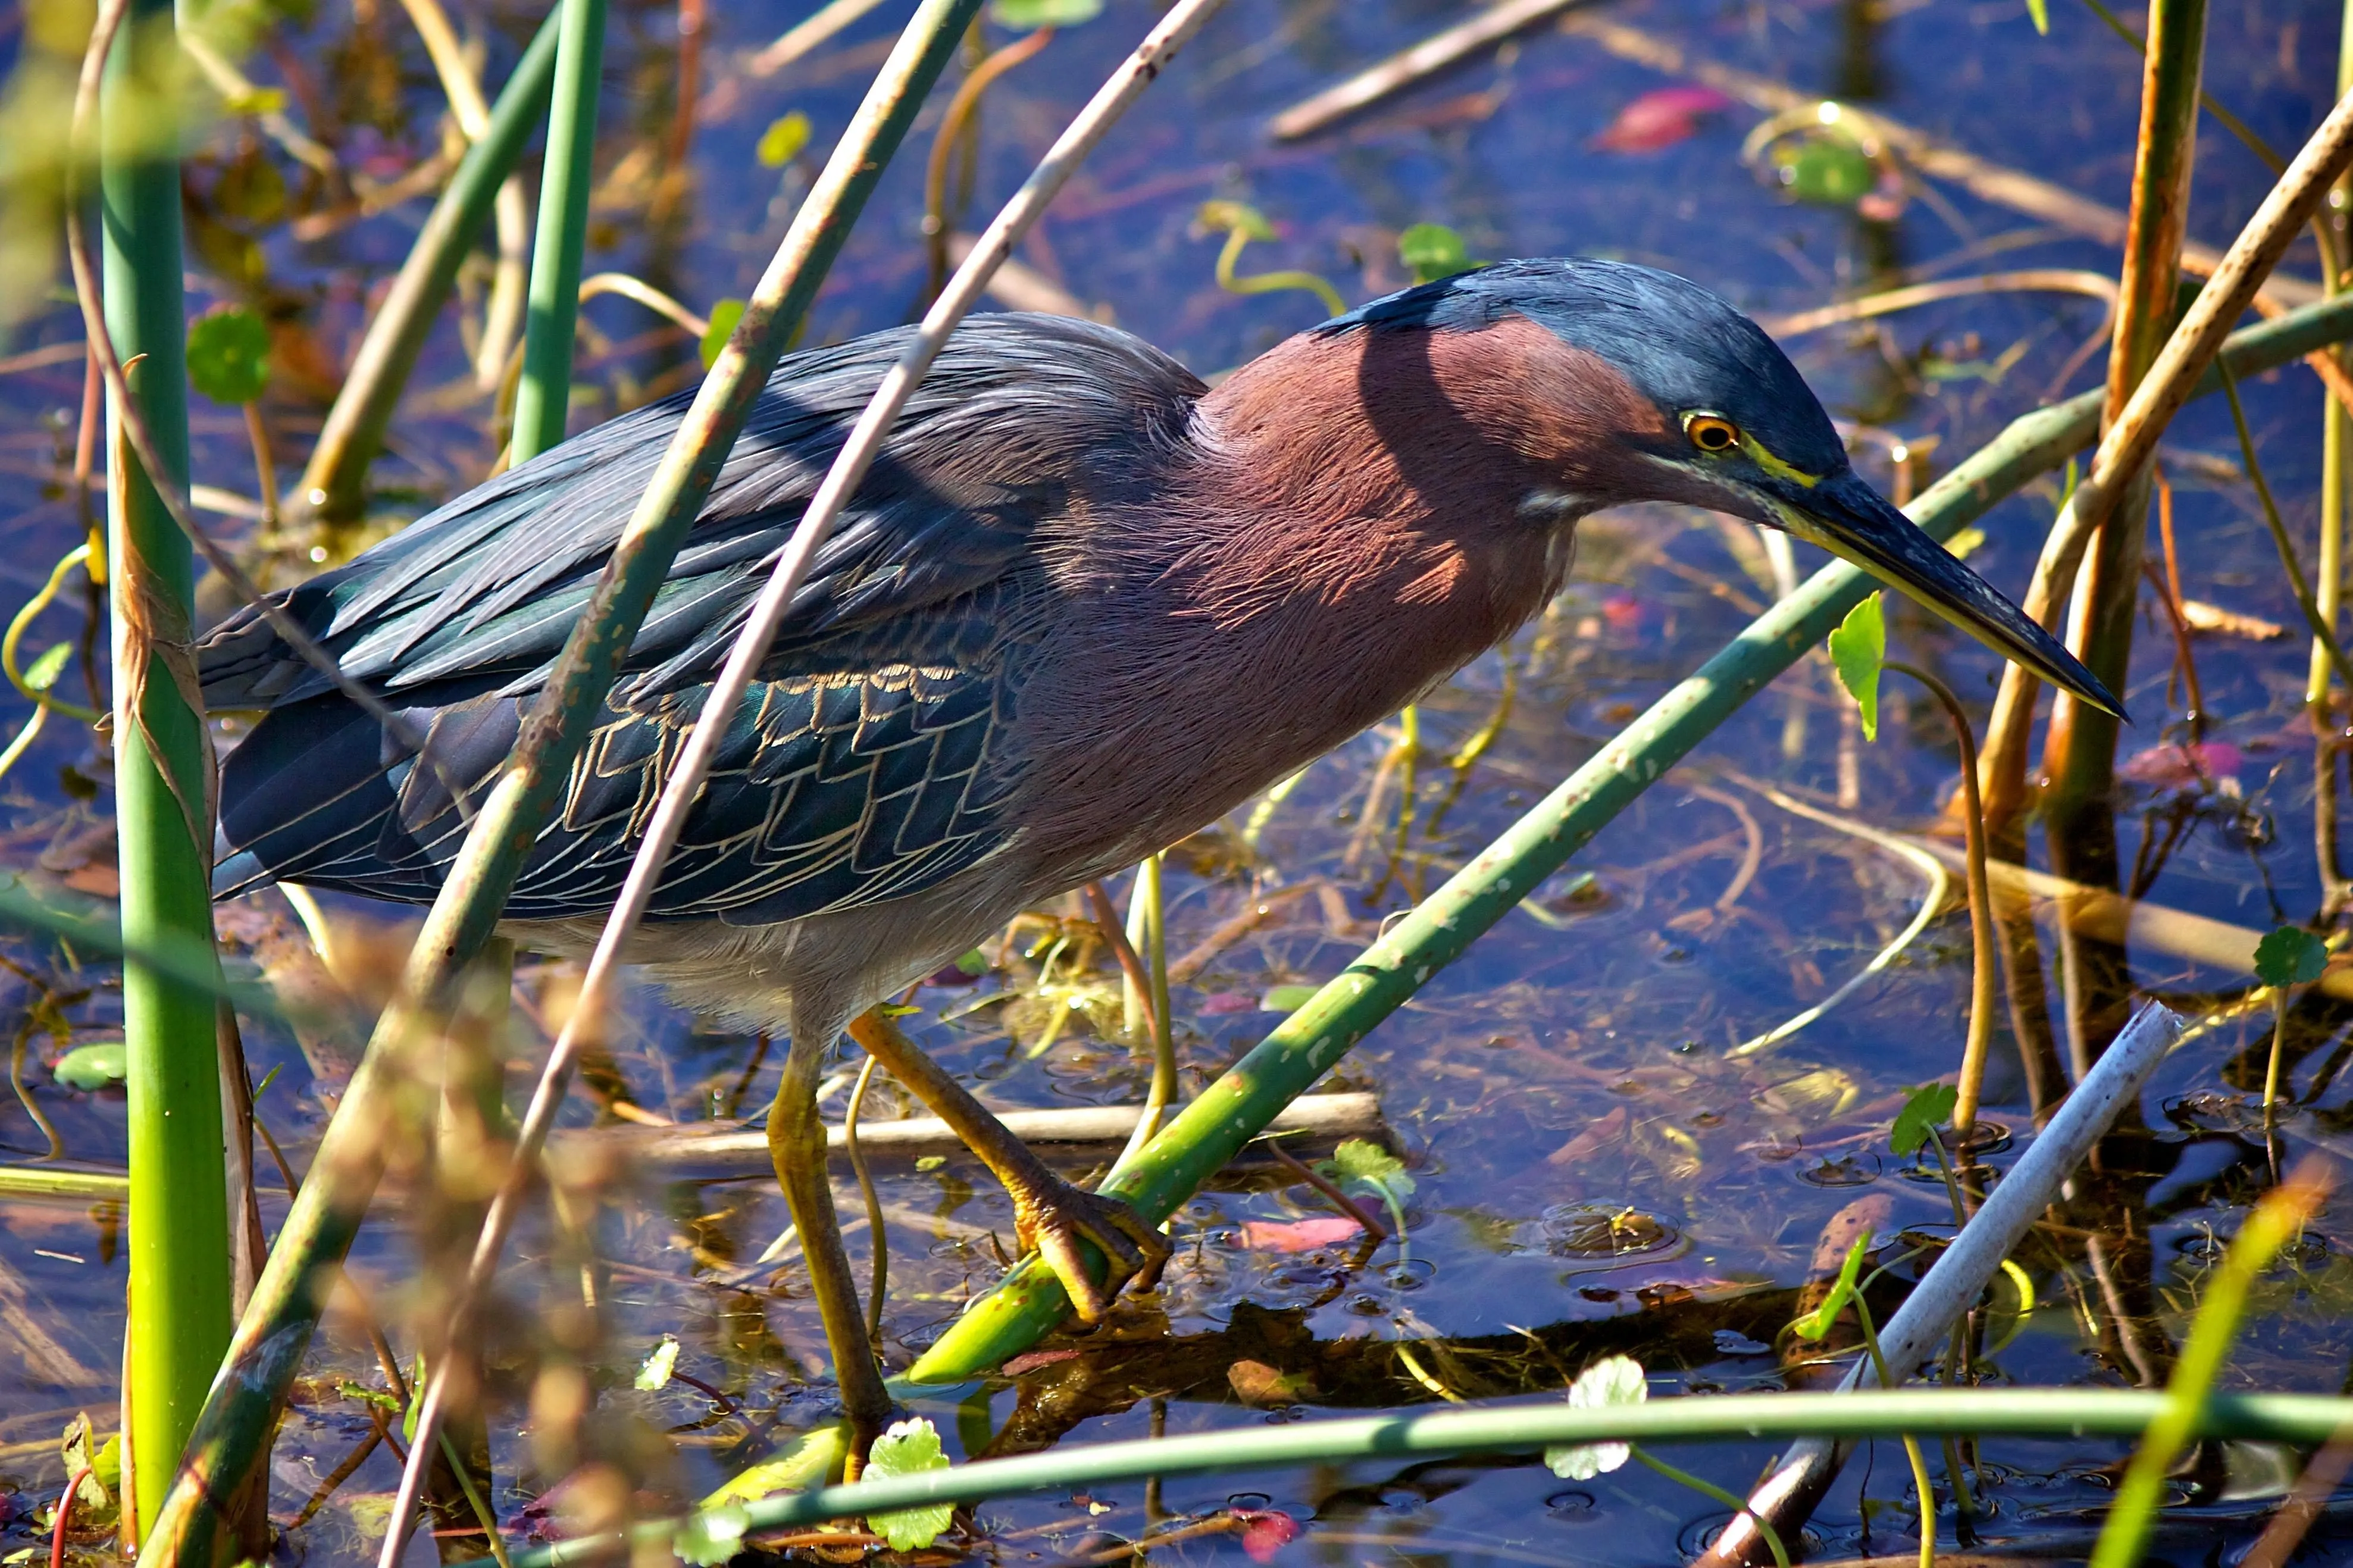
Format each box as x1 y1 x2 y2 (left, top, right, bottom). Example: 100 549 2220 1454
1325 259 2123 713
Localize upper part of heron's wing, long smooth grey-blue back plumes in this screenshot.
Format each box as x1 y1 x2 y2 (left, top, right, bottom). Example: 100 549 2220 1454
198 315 1200 709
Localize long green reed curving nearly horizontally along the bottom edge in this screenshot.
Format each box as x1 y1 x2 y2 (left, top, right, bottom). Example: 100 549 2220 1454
456 1389 2353 1568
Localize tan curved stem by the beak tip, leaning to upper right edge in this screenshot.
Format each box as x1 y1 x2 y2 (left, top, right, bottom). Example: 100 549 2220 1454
1979 76 2353 838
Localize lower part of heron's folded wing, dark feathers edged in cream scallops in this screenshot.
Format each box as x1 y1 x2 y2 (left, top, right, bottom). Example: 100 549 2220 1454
217 664 1019 923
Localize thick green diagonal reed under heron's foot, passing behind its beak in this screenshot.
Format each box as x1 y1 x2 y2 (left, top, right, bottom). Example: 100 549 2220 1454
906 281 2353 1382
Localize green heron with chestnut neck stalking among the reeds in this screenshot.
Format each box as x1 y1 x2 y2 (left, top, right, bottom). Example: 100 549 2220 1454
200 261 2118 1420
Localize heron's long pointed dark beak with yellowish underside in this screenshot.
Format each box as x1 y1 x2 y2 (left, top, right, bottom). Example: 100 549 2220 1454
1774 468 2124 718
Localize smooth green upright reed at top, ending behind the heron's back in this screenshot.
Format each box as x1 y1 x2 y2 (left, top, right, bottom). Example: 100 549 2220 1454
508 0 605 466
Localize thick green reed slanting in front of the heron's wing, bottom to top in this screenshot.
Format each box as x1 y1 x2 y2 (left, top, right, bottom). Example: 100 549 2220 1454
133 0 979 1568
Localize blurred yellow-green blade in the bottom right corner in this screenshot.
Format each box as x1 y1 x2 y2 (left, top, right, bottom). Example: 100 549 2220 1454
2092 1161 2329 1568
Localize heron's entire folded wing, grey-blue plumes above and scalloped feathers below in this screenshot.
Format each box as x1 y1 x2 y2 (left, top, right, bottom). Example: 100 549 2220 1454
200 318 1198 923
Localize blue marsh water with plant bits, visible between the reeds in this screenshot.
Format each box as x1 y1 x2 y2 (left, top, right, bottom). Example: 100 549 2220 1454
0 0 2353 1566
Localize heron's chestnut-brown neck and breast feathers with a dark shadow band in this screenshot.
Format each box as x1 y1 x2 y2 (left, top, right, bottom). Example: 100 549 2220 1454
1024 318 1659 874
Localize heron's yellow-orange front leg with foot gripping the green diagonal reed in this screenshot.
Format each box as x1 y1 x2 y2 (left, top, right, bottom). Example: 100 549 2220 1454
852 1010 1169 1323
